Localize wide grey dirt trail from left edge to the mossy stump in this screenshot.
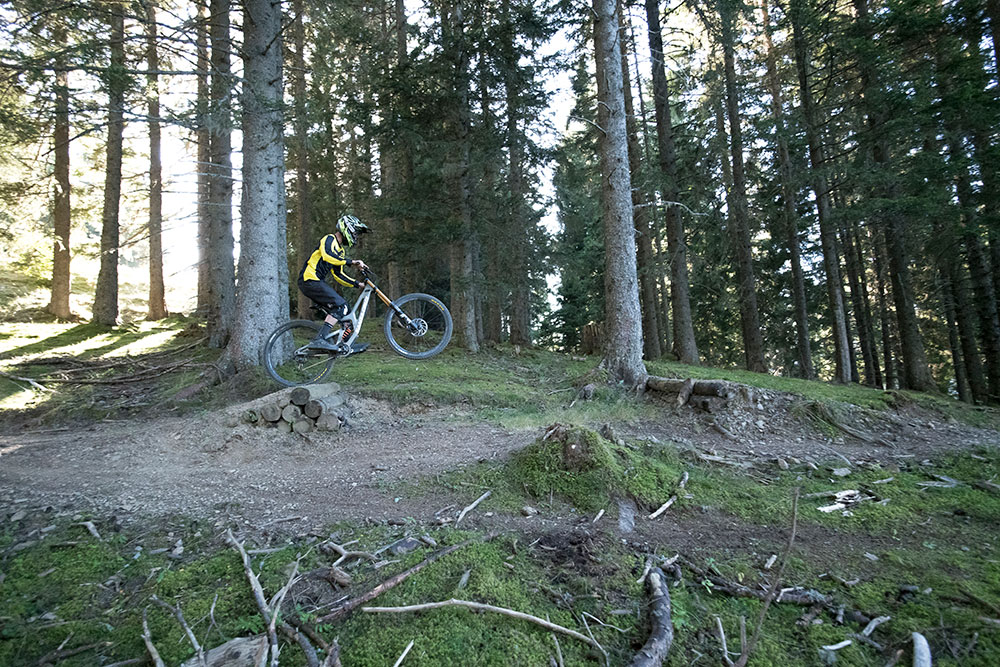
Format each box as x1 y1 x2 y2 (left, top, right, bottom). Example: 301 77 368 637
0 402 534 525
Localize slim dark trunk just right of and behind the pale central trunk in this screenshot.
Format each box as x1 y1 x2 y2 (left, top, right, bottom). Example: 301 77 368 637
618 0 663 359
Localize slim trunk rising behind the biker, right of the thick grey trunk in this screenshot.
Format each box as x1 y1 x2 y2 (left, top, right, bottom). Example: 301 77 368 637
292 0 316 319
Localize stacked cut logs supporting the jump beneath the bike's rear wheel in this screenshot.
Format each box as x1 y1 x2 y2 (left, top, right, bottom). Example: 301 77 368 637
243 382 350 434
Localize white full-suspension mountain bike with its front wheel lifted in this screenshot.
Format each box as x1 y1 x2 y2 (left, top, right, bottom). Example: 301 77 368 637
264 270 454 387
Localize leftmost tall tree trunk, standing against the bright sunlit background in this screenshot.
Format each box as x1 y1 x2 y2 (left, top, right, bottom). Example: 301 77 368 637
48 54 72 320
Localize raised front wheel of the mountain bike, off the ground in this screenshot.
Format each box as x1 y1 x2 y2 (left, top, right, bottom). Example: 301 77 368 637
385 294 454 359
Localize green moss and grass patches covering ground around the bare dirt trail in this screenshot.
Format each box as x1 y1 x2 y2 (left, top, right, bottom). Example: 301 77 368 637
0 318 1000 666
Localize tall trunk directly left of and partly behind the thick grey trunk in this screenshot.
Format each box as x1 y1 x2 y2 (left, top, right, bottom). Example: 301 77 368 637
207 0 236 347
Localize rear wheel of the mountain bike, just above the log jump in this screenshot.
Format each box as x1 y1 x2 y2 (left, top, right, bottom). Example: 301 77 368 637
264 320 336 387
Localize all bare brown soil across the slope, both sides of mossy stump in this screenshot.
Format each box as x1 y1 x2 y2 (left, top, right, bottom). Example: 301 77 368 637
0 384 998 547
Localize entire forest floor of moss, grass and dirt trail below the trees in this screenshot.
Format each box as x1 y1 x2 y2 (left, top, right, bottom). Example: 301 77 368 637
0 318 1000 665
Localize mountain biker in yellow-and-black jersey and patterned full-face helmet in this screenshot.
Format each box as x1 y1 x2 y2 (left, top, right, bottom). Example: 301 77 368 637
298 215 371 352
